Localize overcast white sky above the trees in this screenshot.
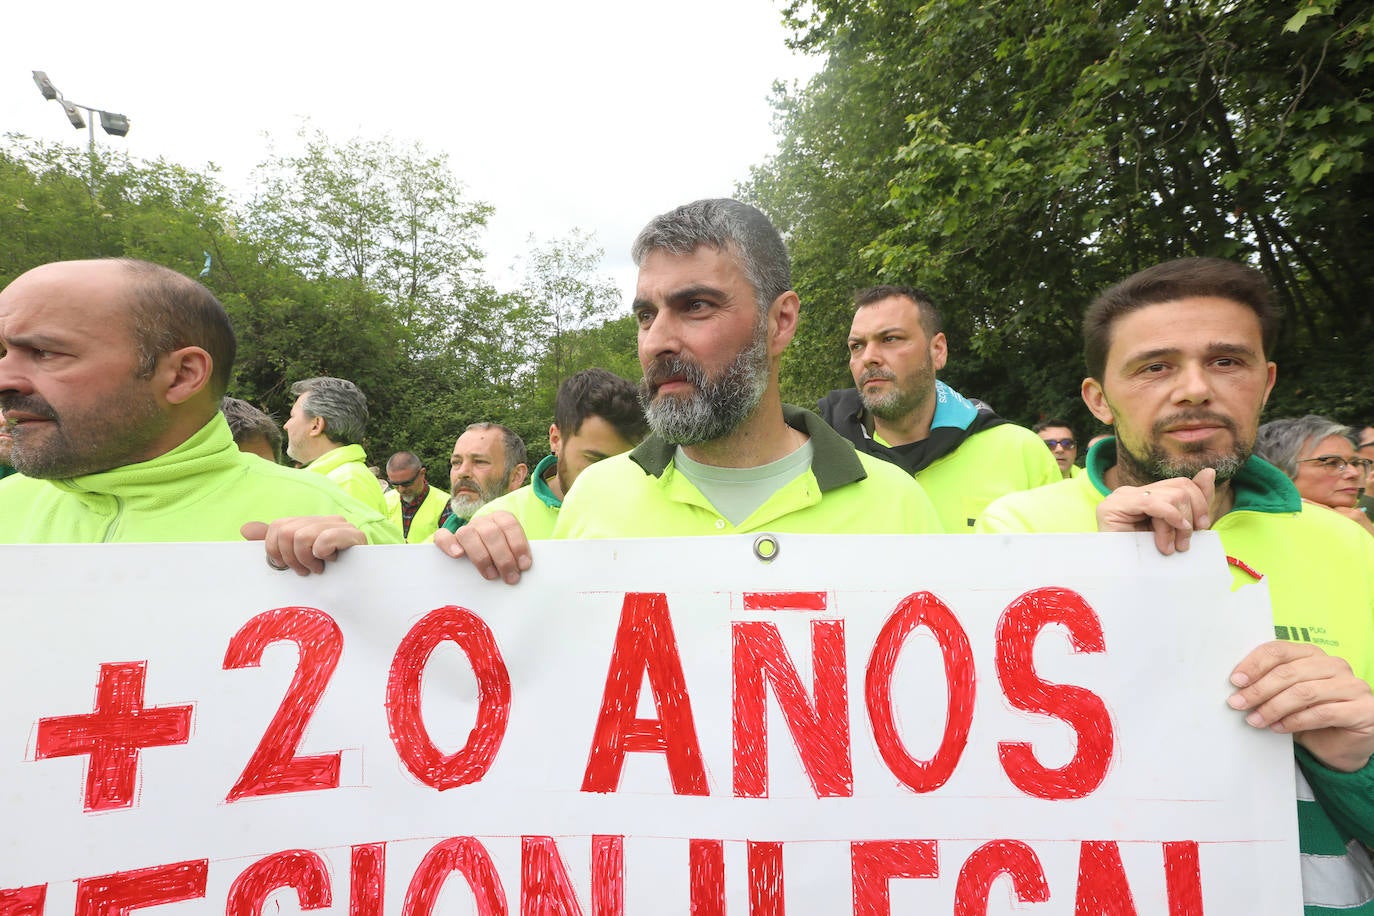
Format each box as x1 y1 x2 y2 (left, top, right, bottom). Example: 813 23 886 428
0 0 819 307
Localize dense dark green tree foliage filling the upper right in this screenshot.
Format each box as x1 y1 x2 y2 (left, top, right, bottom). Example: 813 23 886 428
745 0 1374 431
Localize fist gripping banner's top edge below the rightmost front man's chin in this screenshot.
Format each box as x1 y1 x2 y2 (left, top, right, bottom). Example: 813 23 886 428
1098 467 1216 556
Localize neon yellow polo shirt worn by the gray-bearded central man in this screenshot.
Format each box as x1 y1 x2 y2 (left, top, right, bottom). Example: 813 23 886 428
554 407 939 538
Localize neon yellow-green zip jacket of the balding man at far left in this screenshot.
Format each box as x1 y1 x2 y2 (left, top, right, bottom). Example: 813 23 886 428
0 413 401 544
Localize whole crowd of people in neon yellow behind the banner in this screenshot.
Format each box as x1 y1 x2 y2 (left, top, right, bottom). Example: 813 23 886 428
0 199 1374 916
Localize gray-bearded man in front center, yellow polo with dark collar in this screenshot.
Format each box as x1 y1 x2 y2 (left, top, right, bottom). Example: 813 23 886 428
278 199 945 582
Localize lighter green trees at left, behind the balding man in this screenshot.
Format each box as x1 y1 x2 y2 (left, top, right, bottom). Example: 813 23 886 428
0 135 551 469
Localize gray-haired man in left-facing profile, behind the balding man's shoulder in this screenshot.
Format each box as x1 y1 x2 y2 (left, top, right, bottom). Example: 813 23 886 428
278 375 387 515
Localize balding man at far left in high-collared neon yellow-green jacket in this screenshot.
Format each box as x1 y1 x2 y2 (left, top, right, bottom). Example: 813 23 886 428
0 260 400 553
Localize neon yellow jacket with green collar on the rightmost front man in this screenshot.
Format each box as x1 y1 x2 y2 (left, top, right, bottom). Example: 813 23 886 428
977 439 1374 916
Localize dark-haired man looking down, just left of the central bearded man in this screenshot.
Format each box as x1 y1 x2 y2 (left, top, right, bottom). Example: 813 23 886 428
475 369 649 541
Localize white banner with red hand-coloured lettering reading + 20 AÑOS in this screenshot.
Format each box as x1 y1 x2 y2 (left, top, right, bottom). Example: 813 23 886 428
0 534 1301 916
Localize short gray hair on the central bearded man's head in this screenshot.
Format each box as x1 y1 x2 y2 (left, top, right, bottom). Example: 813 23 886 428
629 198 791 312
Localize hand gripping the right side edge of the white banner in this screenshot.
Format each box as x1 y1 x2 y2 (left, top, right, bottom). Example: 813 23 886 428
1227 640 1374 773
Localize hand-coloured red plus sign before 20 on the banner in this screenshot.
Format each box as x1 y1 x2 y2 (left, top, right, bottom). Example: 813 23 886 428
36 662 192 812
